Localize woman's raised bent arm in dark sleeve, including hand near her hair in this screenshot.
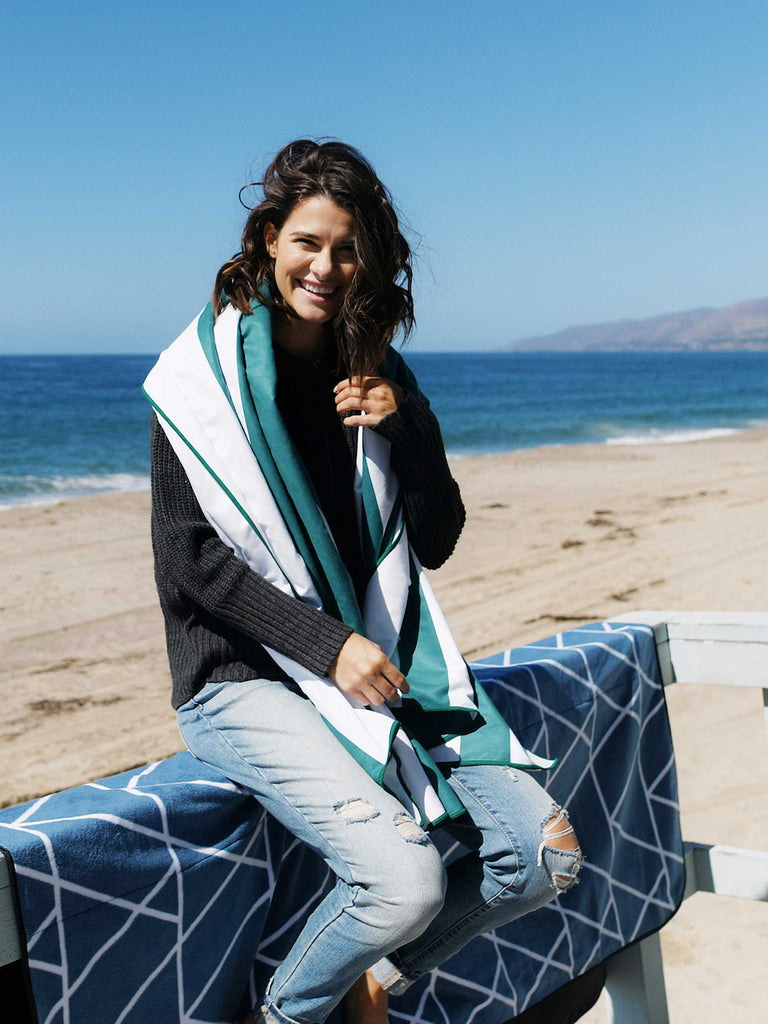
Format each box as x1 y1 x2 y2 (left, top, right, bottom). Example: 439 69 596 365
336 377 466 569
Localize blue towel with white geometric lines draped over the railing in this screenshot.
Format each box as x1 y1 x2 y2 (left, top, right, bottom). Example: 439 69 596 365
0 624 683 1024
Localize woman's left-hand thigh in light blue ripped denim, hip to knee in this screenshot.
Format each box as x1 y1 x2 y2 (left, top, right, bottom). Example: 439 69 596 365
178 679 441 884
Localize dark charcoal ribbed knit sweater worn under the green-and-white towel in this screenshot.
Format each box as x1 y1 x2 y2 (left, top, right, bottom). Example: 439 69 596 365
152 378 465 708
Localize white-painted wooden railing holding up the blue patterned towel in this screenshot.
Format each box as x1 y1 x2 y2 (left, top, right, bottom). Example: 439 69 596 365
605 611 768 1024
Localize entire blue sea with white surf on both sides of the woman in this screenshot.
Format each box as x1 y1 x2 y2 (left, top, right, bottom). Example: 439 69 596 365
0 352 768 508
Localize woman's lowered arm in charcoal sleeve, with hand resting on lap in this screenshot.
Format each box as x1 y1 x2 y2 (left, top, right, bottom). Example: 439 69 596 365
151 415 408 703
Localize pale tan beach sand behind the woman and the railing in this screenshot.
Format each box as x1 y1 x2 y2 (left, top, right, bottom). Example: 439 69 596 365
0 430 768 1024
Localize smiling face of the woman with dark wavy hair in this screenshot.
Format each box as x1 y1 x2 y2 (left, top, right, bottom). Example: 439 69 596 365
264 196 356 327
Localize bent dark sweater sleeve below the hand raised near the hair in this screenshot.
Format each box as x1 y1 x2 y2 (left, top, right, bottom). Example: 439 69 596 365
373 394 466 569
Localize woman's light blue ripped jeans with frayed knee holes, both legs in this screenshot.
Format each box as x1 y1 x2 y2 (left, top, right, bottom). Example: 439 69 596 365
178 679 581 1024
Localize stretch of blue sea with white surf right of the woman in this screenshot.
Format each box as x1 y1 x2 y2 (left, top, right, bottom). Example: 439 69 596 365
409 352 768 454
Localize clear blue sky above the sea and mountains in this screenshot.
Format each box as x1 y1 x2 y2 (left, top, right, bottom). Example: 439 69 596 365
0 0 768 352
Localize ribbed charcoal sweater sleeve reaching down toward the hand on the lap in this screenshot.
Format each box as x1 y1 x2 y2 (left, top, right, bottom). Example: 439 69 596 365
152 416 352 688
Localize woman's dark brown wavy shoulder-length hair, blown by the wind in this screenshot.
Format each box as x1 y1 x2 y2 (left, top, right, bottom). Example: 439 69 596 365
213 139 414 374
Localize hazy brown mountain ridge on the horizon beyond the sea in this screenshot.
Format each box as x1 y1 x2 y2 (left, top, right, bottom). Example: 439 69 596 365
504 299 768 352
